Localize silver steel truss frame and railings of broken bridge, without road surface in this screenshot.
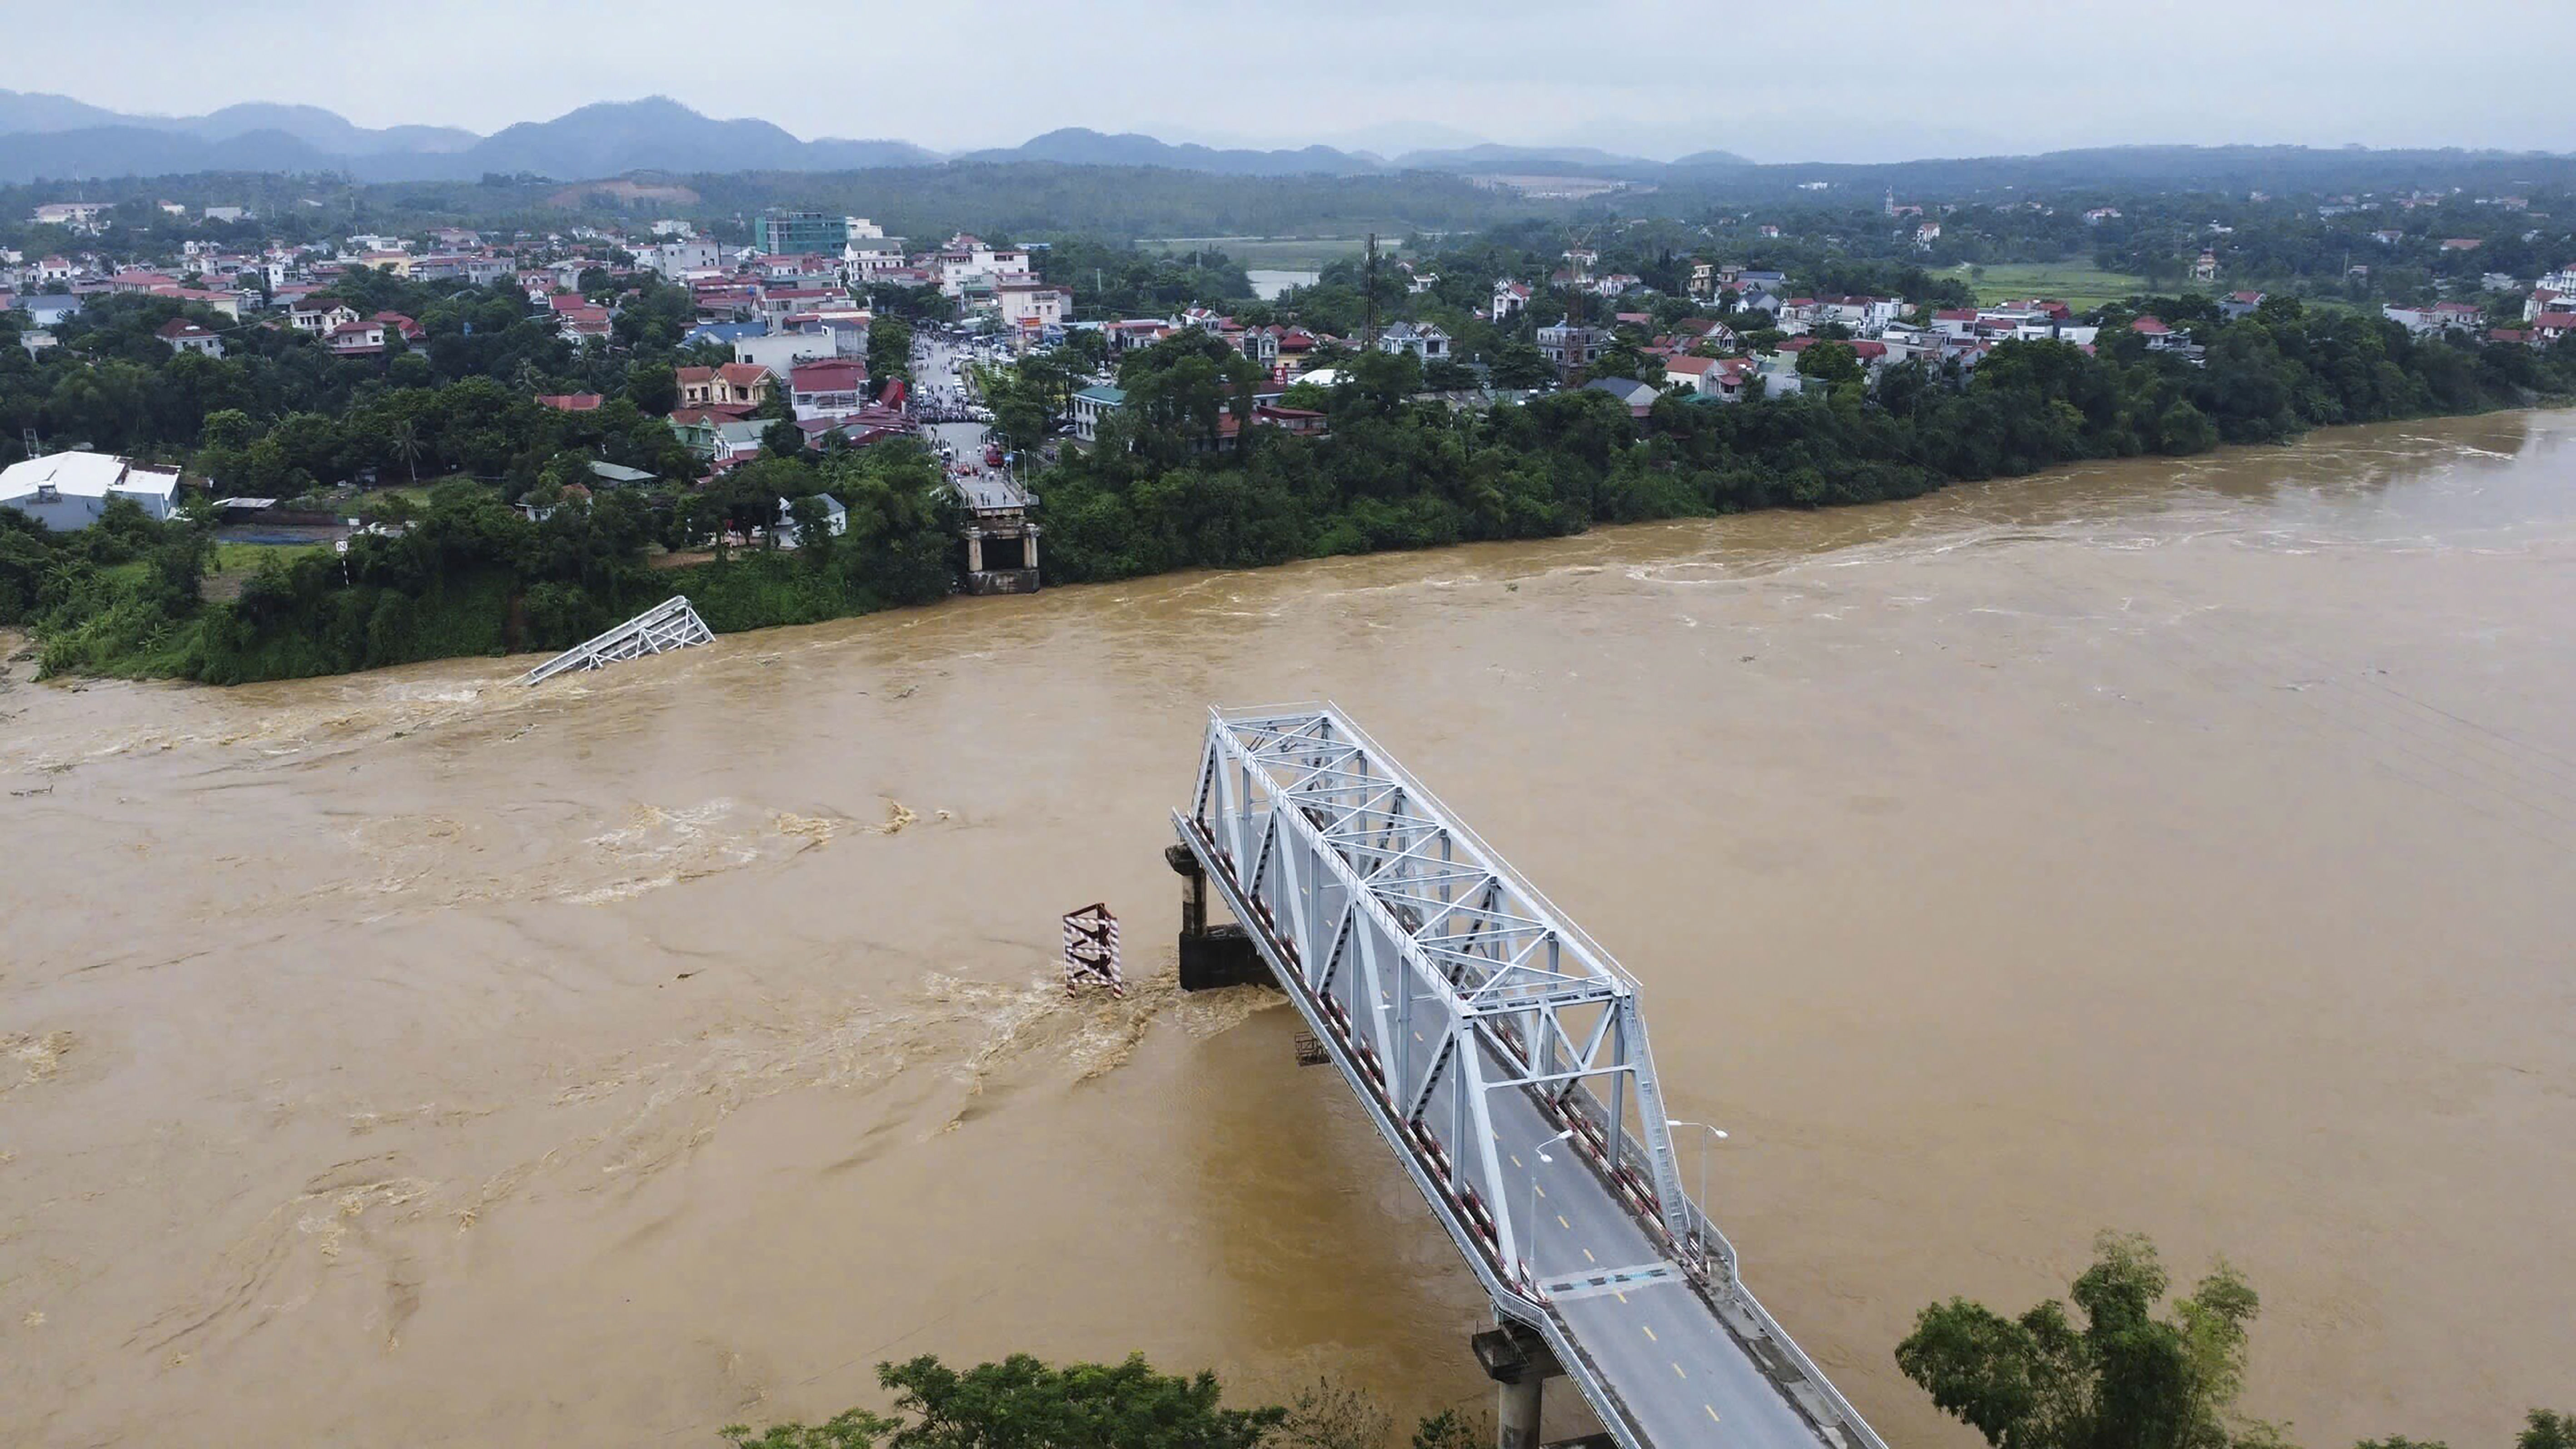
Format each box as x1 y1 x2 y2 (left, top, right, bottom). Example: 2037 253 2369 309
1172 705 1883 1449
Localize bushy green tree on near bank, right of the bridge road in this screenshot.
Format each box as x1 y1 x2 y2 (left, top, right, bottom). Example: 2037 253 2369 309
1896 1233 2277 1449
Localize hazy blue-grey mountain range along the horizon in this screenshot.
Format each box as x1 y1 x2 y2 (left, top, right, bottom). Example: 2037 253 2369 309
0 90 1749 183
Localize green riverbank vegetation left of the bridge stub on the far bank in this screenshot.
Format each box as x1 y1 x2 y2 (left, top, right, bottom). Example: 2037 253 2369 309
0 443 956 685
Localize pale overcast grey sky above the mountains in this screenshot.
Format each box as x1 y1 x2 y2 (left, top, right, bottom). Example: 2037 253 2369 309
0 0 2576 159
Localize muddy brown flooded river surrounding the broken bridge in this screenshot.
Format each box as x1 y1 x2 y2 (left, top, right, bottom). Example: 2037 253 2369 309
0 414 2576 1449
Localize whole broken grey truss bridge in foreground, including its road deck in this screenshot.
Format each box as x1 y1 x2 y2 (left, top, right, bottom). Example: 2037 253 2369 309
1172 705 1886 1449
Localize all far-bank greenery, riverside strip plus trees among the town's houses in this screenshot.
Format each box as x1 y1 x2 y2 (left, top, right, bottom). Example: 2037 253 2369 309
0 200 2576 682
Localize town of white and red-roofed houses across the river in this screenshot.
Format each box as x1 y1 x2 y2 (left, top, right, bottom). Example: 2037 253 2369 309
0 193 2576 587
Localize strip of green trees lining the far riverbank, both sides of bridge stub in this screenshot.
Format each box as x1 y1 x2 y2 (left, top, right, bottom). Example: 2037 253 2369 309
0 299 2576 685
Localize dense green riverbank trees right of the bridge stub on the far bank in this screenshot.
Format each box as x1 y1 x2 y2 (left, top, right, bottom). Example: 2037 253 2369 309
997 296 2576 582
